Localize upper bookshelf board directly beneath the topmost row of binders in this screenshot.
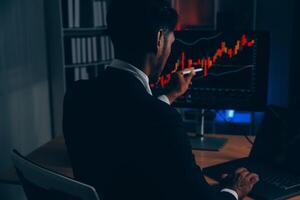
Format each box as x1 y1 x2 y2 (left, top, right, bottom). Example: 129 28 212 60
63 27 107 36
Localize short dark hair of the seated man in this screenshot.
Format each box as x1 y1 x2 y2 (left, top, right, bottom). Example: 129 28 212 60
107 0 178 56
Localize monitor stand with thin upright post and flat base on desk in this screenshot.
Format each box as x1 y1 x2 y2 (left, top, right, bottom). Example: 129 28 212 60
190 109 227 151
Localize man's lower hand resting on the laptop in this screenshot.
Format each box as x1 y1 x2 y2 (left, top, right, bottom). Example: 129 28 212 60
221 168 259 199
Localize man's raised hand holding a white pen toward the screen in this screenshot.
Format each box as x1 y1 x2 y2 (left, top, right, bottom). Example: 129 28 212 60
166 68 195 104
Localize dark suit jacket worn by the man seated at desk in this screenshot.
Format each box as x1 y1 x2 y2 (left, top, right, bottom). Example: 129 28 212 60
63 69 235 200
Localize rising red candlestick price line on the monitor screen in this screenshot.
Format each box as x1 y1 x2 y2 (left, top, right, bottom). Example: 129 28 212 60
159 34 255 87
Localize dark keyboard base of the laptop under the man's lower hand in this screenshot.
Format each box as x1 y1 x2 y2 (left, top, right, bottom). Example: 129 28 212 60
203 158 300 200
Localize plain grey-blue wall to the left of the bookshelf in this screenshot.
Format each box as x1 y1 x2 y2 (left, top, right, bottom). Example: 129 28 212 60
0 0 51 200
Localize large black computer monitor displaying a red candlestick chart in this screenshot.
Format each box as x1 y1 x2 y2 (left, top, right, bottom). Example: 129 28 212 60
153 30 269 110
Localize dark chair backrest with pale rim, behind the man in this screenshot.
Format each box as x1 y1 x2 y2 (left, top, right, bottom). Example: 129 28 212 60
12 150 99 200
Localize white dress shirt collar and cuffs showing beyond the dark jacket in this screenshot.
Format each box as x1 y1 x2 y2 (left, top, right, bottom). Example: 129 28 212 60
108 59 238 200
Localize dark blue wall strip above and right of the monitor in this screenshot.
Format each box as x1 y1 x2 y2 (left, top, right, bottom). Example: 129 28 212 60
257 0 296 106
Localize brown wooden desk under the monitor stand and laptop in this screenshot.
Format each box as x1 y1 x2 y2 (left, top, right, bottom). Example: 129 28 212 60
0 135 300 200
